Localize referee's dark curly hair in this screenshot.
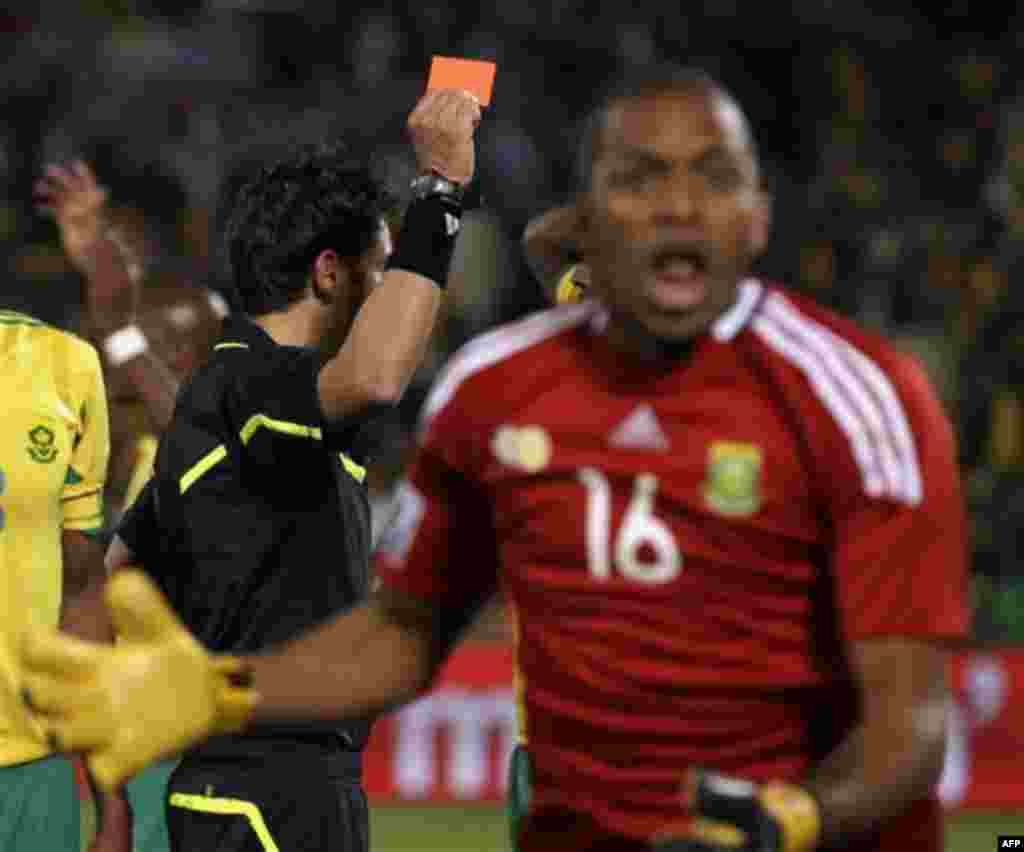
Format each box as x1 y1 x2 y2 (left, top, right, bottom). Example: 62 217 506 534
223 143 395 316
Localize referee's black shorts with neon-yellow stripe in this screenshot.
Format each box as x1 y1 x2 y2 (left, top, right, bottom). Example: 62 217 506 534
167 737 370 852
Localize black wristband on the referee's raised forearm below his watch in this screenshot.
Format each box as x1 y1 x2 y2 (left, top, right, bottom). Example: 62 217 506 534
387 196 462 290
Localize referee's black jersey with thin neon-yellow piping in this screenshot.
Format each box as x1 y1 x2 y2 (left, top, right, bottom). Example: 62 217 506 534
118 316 373 747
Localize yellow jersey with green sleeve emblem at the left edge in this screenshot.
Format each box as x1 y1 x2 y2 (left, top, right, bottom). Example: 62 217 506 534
0 311 110 766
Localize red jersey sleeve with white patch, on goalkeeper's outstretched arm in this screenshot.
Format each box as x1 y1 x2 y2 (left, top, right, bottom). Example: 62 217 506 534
376 368 498 620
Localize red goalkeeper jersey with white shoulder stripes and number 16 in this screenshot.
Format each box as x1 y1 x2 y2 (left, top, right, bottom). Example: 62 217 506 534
381 281 967 850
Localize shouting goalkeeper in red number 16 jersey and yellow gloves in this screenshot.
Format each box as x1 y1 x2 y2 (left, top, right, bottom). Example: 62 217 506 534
24 69 967 852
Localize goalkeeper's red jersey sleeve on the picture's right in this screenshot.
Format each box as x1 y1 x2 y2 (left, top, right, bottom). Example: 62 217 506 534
830 356 969 640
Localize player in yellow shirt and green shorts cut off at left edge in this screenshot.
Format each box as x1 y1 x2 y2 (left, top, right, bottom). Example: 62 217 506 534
0 311 126 850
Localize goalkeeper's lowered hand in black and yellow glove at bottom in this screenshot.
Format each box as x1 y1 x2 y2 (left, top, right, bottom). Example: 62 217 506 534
654 770 821 852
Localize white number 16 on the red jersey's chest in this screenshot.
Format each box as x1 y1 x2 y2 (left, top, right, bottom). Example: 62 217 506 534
577 467 683 585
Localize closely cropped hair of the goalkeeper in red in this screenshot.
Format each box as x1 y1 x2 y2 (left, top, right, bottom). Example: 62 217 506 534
575 62 758 193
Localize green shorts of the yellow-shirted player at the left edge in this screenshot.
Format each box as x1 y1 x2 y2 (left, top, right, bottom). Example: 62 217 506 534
0 757 82 852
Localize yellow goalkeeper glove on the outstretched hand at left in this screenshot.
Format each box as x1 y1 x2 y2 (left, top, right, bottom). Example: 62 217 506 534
20 569 258 792
